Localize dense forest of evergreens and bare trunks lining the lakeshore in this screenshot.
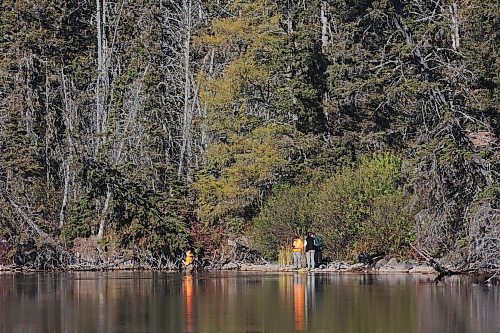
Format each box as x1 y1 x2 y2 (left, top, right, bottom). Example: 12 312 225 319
0 0 500 271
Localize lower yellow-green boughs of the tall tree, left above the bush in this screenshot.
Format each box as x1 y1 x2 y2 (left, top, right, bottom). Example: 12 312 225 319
194 124 317 224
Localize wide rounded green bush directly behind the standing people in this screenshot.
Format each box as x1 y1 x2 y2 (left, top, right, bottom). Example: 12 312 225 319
253 153 413 259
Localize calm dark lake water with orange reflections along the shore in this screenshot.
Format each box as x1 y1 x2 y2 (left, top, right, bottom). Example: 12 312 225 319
0 272 500 333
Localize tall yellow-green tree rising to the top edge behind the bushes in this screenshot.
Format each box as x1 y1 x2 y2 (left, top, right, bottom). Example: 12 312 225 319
195 1 332 231
